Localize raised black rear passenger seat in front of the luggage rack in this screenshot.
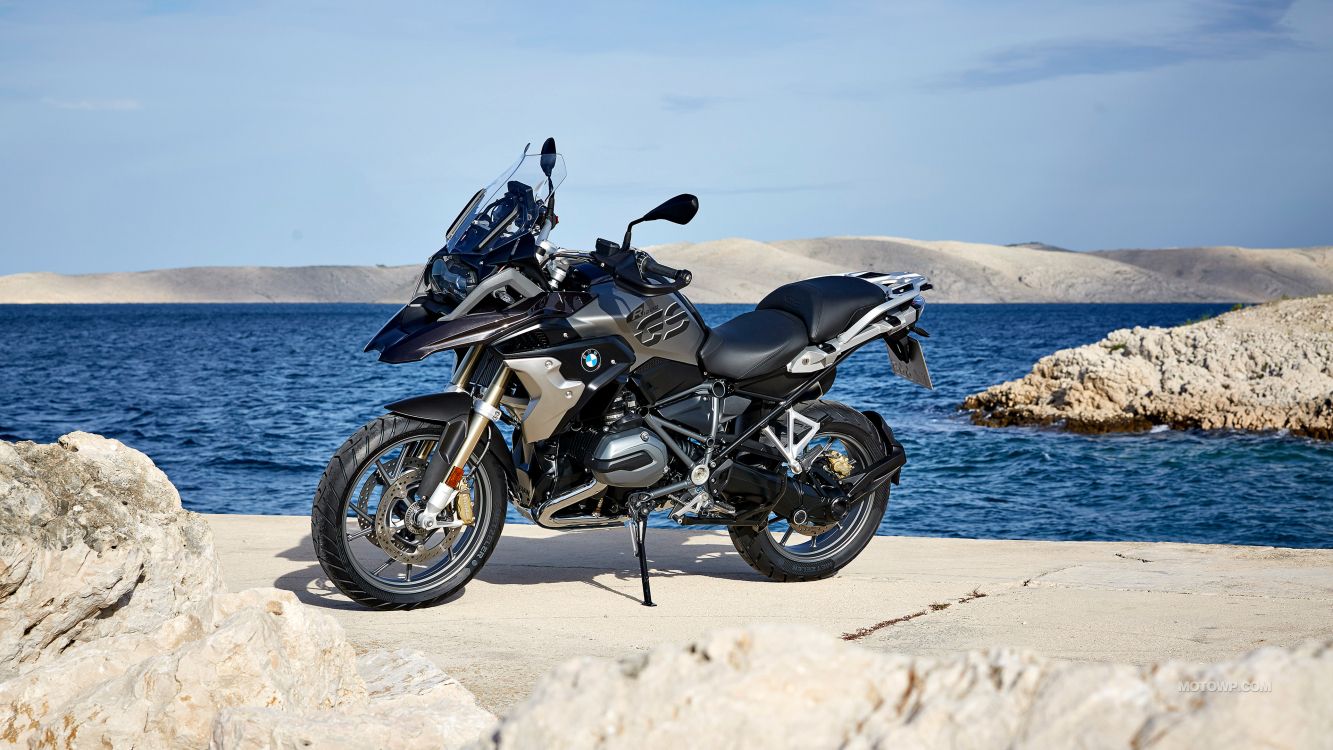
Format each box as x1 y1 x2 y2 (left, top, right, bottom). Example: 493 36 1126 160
754 276 886 344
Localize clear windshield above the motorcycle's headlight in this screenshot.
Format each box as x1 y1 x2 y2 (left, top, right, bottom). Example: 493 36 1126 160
444 153 565 254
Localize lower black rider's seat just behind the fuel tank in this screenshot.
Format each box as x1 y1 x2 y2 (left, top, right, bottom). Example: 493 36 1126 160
698 310 808 380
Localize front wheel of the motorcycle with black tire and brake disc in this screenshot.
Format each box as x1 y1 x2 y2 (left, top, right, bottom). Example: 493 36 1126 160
311 414 508 609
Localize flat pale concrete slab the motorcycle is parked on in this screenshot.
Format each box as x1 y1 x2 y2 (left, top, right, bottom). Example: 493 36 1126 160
204 514 1333 713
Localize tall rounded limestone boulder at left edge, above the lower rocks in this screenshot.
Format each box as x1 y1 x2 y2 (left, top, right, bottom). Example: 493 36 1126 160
0 433 223 678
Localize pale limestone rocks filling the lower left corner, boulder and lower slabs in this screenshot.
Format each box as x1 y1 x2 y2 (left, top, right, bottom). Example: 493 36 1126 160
0 433 495 747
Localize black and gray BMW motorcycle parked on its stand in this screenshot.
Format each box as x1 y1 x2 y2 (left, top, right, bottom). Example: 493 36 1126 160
311 139 930 609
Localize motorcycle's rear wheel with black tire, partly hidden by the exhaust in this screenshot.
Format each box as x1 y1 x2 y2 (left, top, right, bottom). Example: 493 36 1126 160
728 400 889 582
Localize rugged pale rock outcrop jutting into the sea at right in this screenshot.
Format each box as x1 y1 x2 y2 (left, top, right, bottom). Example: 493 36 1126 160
962 296 1333 440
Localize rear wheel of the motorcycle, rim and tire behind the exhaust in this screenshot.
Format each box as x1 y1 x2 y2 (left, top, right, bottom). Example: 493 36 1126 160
729 401 889 581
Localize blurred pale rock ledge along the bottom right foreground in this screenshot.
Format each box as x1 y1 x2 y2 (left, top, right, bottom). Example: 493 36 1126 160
483 626 1333 750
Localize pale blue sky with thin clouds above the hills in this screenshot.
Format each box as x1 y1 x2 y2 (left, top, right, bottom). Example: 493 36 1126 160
0 0 1333 273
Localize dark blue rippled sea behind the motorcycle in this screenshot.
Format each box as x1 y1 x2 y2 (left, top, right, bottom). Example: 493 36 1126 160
0 305 1333 548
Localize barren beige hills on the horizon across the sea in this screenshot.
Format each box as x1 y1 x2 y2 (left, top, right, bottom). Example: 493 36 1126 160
0 237 1333 304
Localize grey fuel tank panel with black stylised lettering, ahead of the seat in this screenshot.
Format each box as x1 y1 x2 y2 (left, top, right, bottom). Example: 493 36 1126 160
569 281 705 369
